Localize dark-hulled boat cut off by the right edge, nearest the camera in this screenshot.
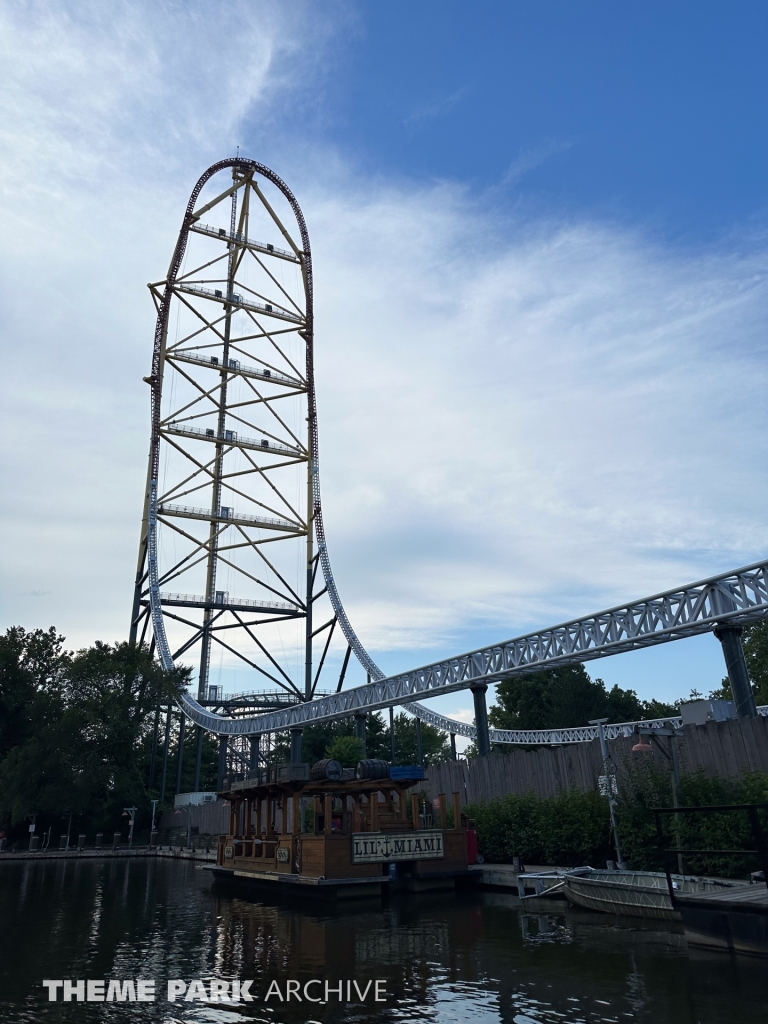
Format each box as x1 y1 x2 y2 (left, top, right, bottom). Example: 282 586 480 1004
674 882 768 956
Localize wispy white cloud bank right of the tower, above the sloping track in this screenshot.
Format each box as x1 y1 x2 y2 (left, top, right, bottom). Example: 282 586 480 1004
311 177 768 650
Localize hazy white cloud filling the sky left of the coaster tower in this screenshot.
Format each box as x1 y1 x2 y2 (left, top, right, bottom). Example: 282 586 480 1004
0 0 337 644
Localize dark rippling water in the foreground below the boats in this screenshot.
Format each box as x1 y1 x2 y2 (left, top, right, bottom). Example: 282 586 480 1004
0 859 768 1024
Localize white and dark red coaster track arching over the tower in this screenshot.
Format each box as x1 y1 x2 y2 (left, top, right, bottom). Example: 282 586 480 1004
138 158 768 743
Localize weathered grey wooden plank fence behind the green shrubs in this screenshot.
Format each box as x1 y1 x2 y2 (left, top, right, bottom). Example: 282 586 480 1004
424 717 768 803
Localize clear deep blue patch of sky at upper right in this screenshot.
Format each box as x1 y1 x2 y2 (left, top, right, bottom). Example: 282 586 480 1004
256 0 768 245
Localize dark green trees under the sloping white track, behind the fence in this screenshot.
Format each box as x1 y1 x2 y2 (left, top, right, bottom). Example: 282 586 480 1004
488 665 678 729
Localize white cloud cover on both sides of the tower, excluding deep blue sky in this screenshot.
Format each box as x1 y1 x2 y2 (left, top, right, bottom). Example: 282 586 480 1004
0 2 767 704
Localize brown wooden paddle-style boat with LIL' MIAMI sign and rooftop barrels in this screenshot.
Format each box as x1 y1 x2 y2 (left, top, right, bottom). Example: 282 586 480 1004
212 762 470 897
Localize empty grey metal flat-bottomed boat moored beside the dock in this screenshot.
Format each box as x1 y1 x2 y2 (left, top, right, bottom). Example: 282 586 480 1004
562 868 740 921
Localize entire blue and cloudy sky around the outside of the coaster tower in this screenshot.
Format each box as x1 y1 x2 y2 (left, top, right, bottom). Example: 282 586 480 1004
0 0 768 737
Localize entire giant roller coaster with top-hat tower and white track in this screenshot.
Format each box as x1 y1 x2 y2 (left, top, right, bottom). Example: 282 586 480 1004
130 157 768 786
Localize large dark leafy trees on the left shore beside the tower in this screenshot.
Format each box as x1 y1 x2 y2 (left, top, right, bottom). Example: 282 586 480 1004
0 627 188 827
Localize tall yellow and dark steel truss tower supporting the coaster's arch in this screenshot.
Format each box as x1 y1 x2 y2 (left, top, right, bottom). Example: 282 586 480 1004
130 159 346 720
